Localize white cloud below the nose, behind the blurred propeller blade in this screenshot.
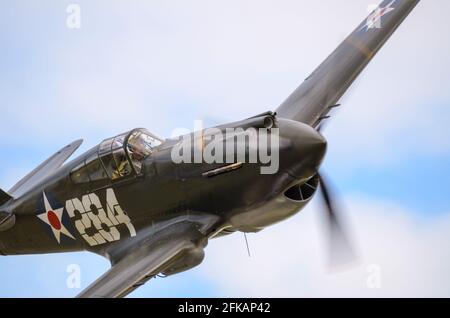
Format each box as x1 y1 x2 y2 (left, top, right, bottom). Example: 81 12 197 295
202 198 450 297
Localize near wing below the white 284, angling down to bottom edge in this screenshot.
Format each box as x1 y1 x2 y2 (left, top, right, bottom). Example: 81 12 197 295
77 218 212 298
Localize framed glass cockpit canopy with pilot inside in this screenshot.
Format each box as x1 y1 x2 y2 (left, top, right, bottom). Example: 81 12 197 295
71 129 163 183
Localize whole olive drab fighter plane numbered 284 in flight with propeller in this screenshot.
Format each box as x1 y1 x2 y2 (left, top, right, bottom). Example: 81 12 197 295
0 0 419 297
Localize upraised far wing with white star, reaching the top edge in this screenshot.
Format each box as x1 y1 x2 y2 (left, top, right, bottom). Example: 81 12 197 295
277 0 419 127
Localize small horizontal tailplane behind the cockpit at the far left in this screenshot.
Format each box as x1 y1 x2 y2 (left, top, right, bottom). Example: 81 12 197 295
8 140 83 197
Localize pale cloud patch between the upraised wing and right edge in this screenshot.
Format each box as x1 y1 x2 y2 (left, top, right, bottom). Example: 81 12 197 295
326 1 450 165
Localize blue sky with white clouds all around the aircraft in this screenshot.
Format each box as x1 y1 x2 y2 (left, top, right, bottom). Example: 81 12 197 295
0 0 450 297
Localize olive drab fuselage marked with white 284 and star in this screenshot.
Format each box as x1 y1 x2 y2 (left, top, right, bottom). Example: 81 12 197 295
0 114 325 255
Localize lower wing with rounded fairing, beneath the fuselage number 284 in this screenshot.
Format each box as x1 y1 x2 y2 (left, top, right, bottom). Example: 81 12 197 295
77 215 217 298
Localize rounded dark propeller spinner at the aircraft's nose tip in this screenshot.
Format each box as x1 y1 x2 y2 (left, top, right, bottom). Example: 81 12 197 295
282 120 327 179
